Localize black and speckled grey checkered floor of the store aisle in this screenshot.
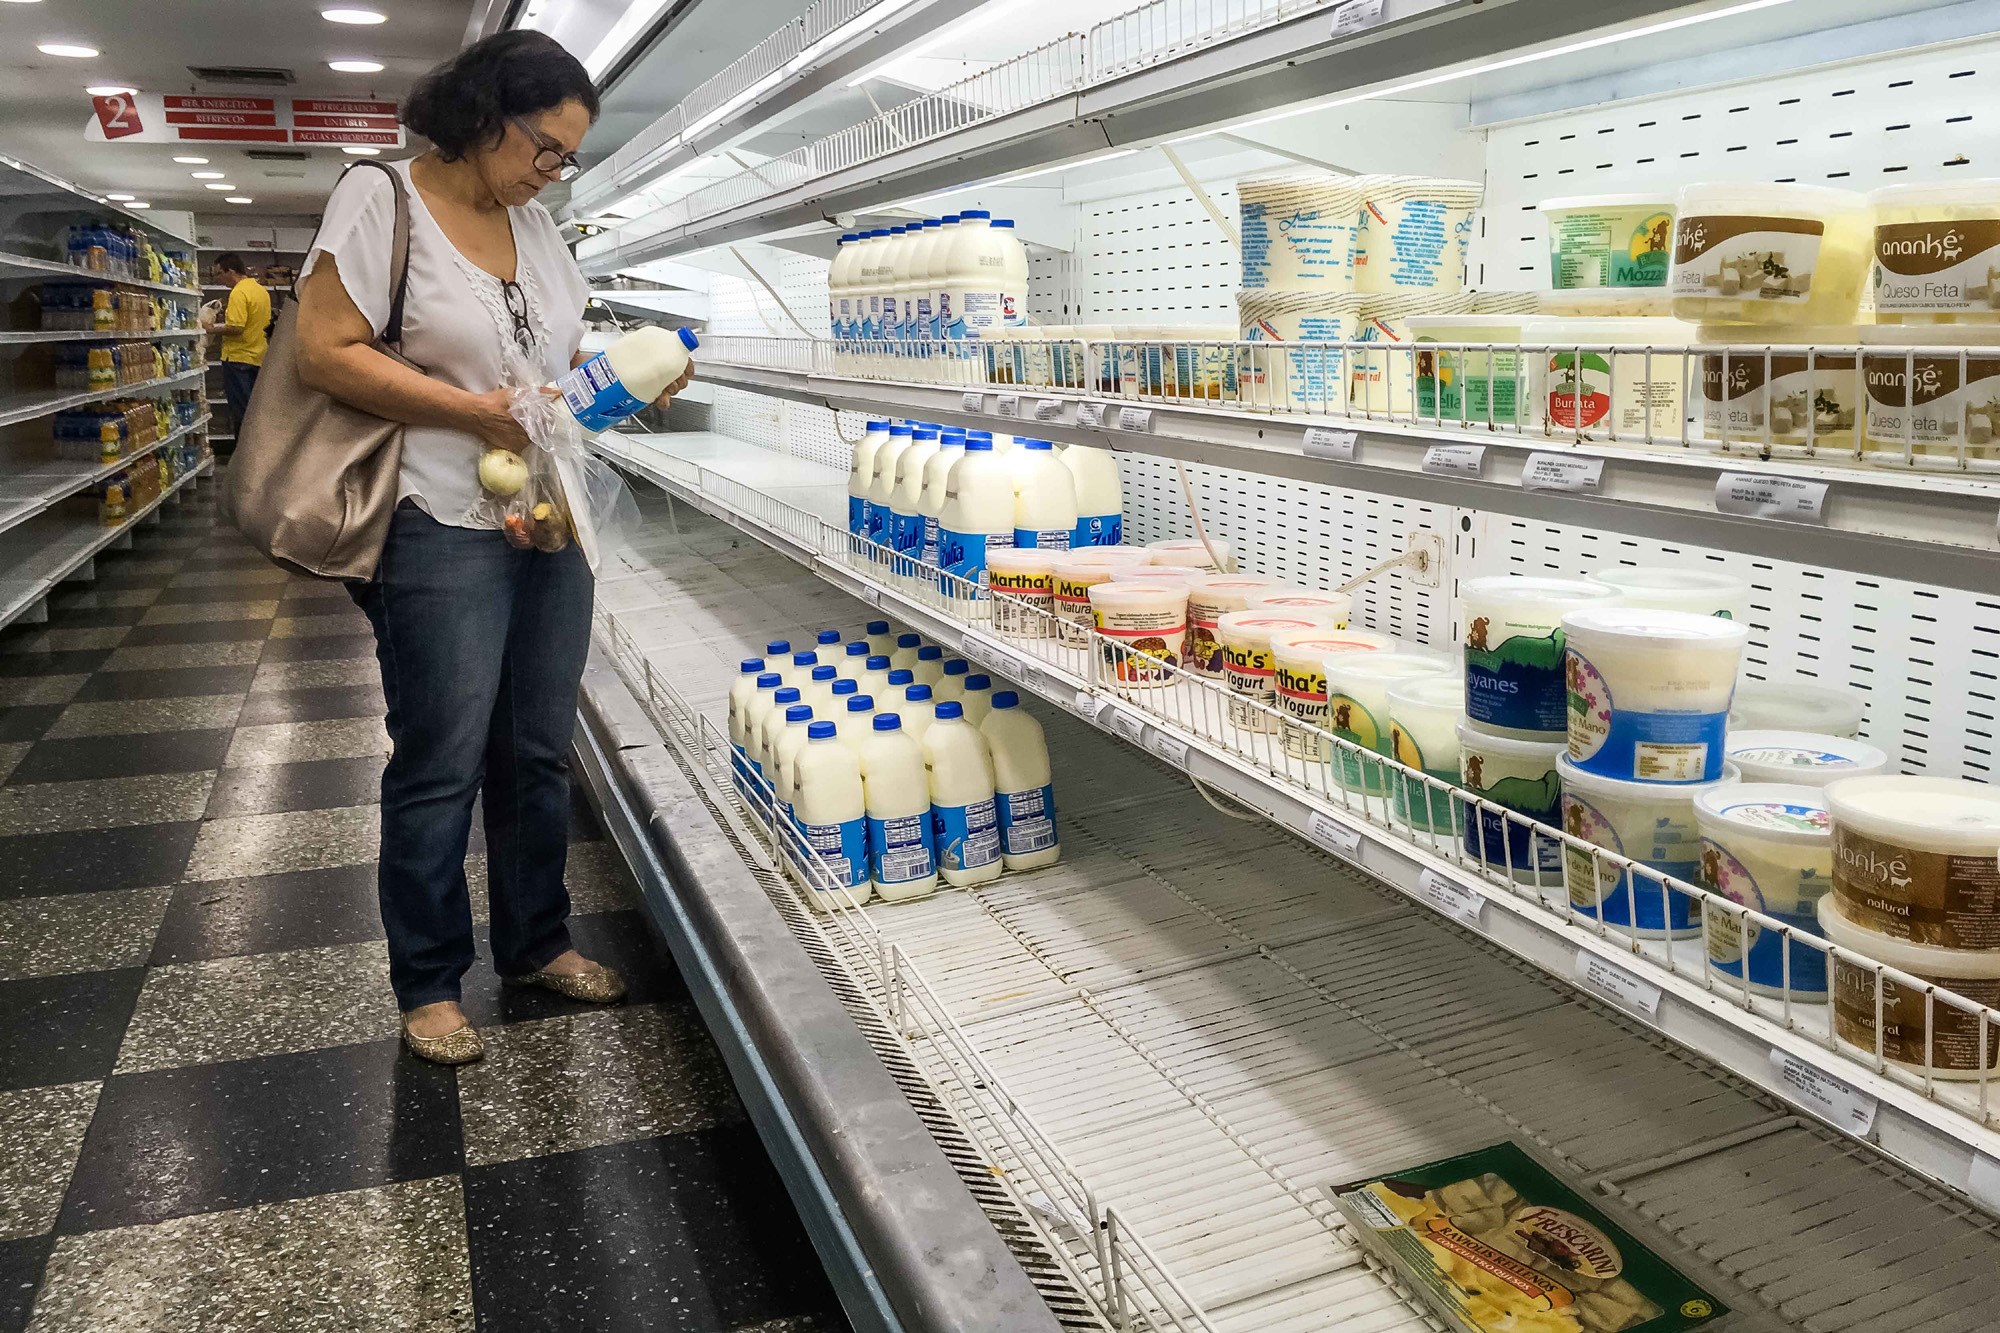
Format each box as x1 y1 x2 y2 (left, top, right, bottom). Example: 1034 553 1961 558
0 484 846 1333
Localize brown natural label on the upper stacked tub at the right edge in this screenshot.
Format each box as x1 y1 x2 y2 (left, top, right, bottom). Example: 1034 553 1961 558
1834 823 2000 949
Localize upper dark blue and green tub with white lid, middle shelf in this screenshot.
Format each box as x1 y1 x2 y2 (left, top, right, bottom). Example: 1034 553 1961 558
1460 574 1618 741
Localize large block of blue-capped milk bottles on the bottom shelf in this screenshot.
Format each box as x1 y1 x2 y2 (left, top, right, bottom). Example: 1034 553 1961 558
730 620 1062 911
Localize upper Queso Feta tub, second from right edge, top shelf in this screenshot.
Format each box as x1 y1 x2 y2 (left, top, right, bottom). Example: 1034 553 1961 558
1668 184 1872 324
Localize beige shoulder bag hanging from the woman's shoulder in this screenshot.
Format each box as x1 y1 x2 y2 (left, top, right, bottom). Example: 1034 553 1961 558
222 162 422 578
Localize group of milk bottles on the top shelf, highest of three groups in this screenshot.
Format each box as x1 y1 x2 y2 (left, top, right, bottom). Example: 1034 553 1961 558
826 208 1028 372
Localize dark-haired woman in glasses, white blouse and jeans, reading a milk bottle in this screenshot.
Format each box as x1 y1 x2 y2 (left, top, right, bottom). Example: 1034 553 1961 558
282 32 686 1063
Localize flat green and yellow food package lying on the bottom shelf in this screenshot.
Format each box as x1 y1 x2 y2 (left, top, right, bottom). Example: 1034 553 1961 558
1326 1143 1728 1333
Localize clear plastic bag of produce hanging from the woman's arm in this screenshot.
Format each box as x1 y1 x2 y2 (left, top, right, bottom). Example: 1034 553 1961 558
480 354 640 572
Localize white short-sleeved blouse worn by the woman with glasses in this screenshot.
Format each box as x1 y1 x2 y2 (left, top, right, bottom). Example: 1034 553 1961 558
300 162 590 528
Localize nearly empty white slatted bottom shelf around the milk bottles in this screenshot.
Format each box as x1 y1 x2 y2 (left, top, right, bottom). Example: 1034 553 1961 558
584 492 2000 1333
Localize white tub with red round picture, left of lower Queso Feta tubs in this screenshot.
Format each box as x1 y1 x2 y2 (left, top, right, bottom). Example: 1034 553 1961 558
1522 318 1696 444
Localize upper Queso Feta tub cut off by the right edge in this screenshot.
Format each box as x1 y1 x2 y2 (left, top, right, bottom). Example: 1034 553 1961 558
1868 180 2000 324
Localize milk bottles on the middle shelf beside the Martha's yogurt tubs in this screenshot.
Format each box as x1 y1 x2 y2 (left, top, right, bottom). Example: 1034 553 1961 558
848 418 1124 598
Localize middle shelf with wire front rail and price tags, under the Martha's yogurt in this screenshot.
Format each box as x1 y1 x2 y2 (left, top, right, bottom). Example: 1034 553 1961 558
596 422 2000 1209
